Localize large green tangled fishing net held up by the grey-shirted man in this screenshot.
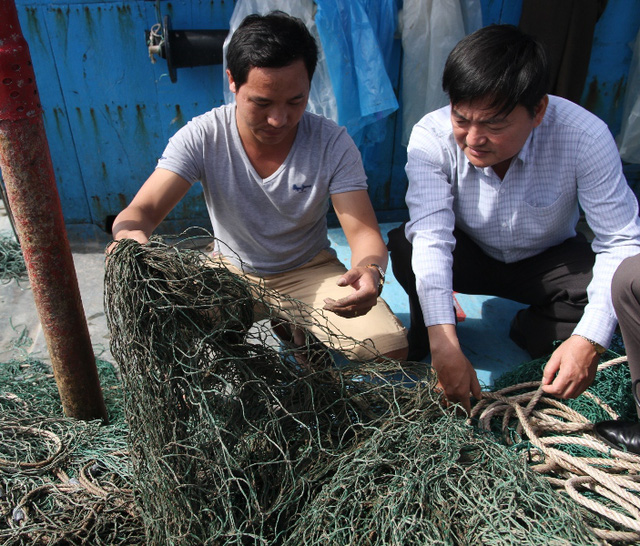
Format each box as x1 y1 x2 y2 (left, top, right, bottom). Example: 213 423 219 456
105 235 597 545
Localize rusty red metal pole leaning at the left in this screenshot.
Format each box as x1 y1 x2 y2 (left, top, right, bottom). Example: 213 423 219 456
0 0 107 423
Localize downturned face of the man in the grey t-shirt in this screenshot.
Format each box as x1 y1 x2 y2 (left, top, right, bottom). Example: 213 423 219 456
227 60 310 147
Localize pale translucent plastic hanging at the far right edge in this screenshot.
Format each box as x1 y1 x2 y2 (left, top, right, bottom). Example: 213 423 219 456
616 27 640 163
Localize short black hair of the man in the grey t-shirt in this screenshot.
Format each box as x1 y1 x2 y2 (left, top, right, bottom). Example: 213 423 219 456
227 11 318 88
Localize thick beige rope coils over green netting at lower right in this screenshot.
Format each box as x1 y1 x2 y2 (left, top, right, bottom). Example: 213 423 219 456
470 357 640 542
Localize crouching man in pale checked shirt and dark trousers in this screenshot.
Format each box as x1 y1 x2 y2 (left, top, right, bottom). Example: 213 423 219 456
389 25 640 410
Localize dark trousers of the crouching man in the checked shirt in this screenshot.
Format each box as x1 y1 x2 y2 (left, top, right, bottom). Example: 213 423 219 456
388 224 595 358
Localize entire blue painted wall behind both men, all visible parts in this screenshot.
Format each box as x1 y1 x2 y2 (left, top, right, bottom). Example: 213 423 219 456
10 0 640 238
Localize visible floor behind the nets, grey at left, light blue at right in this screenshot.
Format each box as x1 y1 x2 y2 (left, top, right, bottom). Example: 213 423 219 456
0 201 529 386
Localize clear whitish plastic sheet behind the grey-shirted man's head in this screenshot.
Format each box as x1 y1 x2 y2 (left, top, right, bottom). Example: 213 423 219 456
223 0 338 122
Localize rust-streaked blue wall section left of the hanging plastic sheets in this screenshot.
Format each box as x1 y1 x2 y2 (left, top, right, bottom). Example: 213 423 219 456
16 0 234 235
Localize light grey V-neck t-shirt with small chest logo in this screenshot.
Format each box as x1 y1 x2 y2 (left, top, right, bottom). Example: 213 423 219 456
157 104 367 275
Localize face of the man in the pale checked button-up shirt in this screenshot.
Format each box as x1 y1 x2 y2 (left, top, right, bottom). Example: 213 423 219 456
451 95 549 177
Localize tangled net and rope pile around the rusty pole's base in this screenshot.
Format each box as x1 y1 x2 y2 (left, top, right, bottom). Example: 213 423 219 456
0 357 146 546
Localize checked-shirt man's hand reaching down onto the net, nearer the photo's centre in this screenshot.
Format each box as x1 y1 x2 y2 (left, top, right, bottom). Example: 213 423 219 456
429 324 482 414
